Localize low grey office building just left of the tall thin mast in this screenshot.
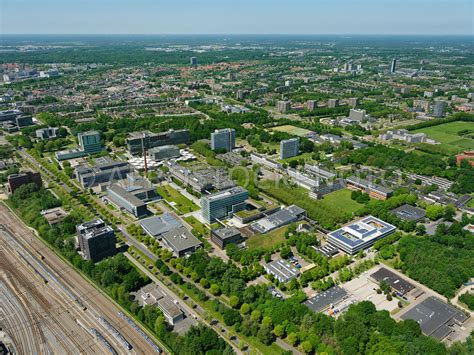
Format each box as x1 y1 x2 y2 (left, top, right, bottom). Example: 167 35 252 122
75 157 132 189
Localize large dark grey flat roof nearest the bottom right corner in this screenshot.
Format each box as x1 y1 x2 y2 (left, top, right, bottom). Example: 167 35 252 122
400 296 468 340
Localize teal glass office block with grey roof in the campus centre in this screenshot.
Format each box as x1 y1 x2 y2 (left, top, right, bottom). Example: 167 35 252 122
201 186 249 223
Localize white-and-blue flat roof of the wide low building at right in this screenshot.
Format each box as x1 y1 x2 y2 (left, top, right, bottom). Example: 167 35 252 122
328 216 396 248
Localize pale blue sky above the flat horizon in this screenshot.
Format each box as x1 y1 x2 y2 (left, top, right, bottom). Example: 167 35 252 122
0 0 474 35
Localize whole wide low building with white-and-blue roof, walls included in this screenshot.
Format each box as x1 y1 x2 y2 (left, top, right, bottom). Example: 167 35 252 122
327 216 396 255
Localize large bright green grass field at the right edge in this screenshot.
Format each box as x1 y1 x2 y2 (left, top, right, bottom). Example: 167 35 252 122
412 122 474 154
